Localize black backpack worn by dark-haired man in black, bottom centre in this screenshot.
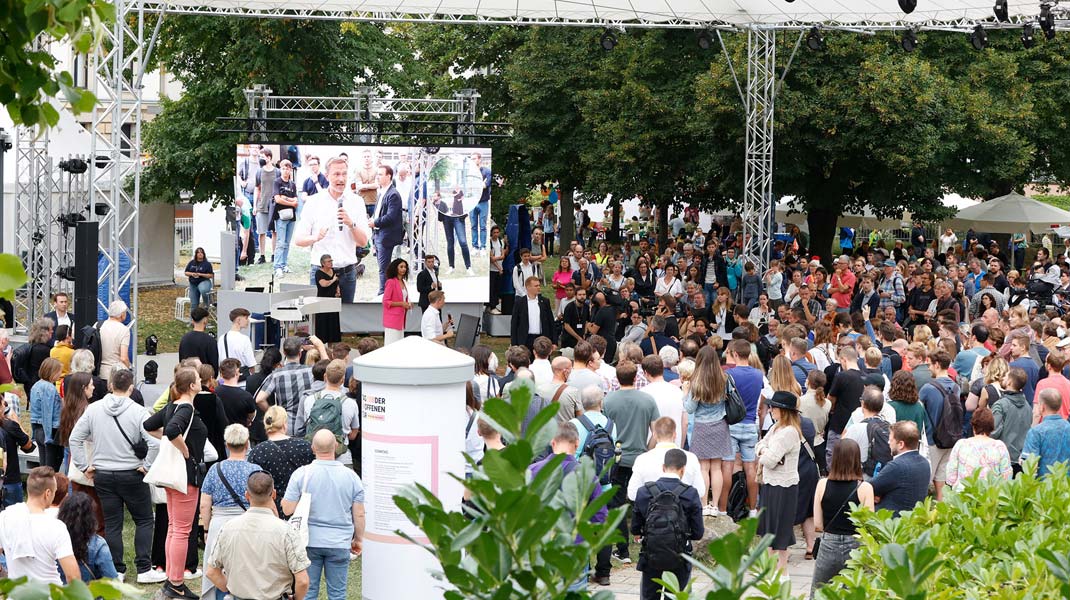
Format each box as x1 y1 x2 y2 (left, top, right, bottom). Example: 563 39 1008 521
642 481 690 572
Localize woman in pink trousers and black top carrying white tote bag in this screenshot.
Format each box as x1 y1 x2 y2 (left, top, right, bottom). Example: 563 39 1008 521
144 368 208 600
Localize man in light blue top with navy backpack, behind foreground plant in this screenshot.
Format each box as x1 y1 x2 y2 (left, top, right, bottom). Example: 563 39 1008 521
569 385 616 585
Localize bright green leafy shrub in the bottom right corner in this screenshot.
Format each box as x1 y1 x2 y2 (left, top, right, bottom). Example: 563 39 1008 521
817 460 1070 600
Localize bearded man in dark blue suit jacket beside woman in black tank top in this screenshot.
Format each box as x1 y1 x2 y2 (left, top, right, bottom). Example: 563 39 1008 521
871 420 932 516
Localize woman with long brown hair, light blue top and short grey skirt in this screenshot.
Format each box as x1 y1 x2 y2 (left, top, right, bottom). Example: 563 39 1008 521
684 345 732 517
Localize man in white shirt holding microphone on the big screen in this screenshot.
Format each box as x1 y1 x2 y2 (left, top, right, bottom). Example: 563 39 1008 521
293 156 371 303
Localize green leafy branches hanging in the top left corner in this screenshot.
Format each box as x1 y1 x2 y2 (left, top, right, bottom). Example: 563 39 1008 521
0 0 116 127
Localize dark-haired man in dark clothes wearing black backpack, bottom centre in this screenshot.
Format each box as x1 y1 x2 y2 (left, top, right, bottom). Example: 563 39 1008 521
631 448 705 600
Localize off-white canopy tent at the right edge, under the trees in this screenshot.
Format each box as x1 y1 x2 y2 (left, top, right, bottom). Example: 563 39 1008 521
947 194 1070 233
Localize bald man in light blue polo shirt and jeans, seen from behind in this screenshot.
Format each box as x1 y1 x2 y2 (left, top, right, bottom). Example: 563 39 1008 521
282 429 364 600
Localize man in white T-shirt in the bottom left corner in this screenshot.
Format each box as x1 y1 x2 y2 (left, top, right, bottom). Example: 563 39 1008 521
0 466 81 585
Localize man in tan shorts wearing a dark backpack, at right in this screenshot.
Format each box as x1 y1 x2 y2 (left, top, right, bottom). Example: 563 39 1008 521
918 350 965 502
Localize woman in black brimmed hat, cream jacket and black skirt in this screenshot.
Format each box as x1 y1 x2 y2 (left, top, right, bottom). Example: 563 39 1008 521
754 391 803 576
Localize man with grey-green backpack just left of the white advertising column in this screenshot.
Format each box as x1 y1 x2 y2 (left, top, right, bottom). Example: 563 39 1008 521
303 360 361 466
